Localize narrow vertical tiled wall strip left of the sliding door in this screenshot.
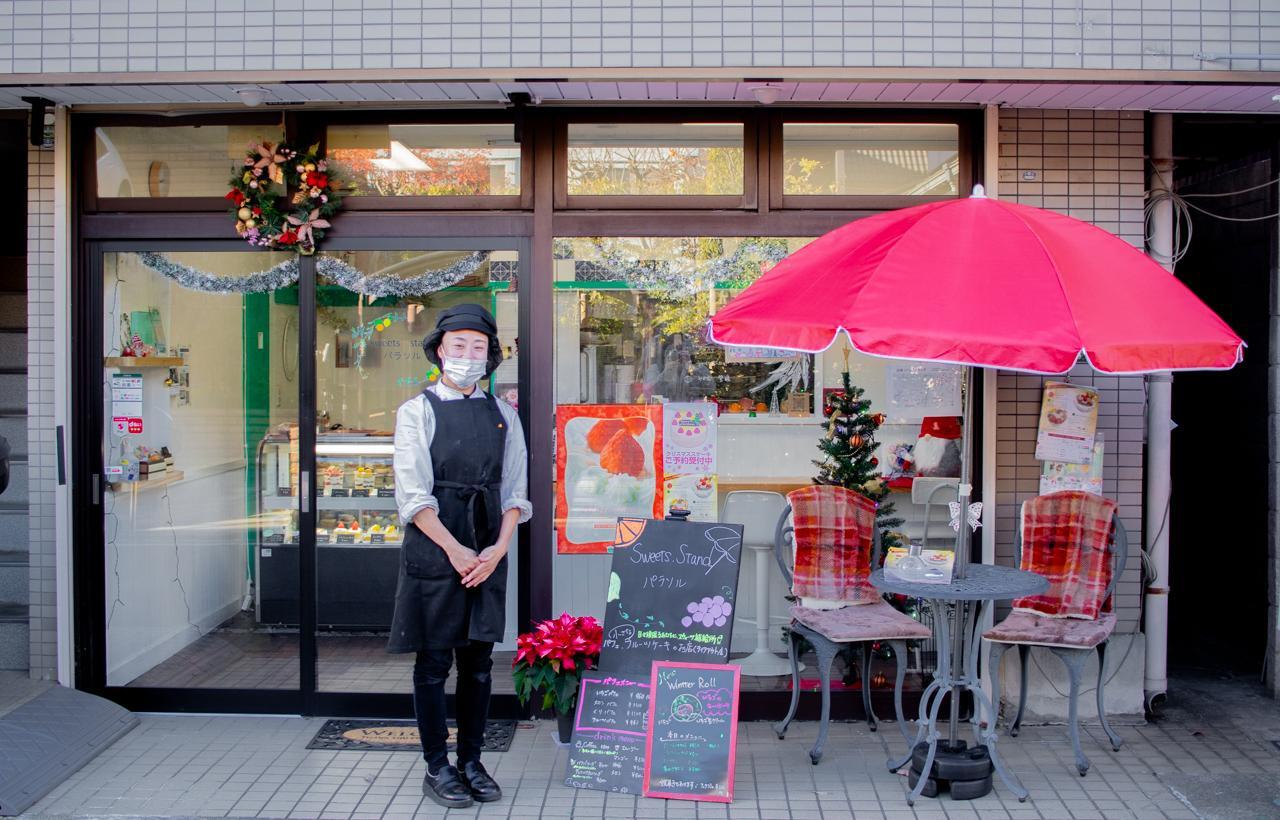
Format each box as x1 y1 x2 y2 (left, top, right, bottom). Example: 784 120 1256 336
27 139 58 681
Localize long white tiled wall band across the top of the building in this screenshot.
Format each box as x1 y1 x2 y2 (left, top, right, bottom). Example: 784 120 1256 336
0 0 1280 73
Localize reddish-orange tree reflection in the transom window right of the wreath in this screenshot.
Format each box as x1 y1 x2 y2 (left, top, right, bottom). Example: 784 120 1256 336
329 148 520 197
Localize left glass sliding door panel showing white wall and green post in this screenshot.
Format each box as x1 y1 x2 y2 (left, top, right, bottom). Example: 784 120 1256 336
95 251 300 690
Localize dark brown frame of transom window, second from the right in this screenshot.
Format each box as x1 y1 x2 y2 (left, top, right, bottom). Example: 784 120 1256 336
552 107 759 211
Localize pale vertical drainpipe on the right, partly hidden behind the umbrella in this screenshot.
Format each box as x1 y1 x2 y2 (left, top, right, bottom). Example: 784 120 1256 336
1143 114 1174 713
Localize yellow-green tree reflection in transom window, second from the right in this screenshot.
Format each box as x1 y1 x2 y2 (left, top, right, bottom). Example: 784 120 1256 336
568 146 742 196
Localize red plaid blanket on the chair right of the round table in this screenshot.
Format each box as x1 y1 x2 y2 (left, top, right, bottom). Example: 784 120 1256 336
1014 490 1116 619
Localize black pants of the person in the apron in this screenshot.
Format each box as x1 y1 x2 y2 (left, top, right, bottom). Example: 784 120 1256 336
413 641 493 771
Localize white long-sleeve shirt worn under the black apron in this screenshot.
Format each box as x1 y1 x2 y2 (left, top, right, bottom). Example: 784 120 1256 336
393 381 534 524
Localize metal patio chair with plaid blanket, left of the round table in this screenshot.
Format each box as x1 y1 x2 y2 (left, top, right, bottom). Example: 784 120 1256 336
774 485 931 765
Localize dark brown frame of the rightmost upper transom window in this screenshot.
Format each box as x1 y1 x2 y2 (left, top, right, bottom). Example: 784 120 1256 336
767 109 982 211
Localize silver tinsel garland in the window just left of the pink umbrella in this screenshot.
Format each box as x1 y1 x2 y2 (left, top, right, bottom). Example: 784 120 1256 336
557 238 790 297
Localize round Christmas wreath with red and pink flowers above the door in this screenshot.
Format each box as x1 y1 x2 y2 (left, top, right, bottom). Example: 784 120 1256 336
225 142 342 256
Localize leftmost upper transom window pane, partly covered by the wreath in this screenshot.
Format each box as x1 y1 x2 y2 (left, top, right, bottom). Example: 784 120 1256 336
93 124 282 198
